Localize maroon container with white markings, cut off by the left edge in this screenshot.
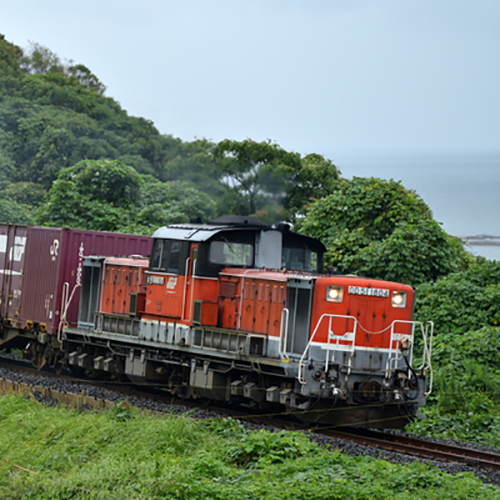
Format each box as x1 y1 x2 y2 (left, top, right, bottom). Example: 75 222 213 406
0 224 28 326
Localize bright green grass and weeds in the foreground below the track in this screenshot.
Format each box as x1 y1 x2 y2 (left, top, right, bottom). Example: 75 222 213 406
0 396 500 500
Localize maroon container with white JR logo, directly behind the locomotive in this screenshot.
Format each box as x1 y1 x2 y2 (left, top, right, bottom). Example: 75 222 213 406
19 226 153 333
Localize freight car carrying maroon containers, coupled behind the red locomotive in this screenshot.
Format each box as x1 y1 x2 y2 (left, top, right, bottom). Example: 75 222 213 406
0 224 153 368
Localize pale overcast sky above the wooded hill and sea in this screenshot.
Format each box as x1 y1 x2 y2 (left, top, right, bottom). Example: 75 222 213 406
0 0 500 254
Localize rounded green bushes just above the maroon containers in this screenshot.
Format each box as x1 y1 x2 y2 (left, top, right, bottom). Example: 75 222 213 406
37 160 216 234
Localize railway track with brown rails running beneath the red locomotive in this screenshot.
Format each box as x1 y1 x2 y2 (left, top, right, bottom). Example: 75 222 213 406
0 356 500 472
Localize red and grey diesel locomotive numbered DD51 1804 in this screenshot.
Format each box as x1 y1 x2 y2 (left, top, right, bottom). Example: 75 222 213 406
0 216 432 427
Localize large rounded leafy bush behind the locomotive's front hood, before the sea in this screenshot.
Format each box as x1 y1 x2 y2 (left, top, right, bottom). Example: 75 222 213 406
297 177 469 284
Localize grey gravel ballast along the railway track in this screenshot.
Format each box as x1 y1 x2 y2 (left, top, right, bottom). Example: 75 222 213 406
0 367 500 485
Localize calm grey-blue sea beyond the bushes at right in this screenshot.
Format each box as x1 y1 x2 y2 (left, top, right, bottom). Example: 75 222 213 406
330 152 500 260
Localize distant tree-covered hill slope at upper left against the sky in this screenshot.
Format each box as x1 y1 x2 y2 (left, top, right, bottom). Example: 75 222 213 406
0 37 177 189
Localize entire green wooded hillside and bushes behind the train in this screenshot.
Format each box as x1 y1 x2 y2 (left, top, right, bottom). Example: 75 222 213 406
0 35 500 466
